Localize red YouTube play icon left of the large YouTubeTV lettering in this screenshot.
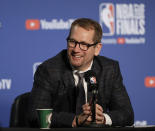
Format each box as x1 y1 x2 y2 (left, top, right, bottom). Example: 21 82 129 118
25 19 40 30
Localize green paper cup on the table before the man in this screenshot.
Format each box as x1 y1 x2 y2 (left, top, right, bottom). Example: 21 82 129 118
36 109 53 129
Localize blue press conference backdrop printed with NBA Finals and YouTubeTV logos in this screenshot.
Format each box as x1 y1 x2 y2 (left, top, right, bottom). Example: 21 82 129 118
0 0 155 127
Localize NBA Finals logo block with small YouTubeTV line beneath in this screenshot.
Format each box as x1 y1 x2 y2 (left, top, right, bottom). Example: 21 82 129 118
99 2 146 45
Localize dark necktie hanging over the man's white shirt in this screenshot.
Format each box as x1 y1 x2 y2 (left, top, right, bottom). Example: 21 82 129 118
76 72 85 115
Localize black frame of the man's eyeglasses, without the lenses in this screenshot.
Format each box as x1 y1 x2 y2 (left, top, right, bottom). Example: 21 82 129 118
66 38 98 51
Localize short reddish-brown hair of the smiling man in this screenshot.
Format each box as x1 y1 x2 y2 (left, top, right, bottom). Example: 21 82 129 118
68 18 102 43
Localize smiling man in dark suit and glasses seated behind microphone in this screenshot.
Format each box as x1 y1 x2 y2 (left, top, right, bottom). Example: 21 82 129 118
29 18 134 127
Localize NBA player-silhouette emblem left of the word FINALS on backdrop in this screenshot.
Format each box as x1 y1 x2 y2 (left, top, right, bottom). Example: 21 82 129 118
99 3 115 36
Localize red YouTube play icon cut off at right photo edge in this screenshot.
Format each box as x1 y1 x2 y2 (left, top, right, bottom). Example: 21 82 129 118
144 76 155 88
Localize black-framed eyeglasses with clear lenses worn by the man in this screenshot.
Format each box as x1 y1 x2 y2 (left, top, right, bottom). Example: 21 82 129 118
66 38 98 51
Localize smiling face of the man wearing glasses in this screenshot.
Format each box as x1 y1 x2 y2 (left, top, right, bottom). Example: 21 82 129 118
68 26 102 71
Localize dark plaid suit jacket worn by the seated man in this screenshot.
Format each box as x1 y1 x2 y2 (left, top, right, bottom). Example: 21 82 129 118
28 50 134 127
